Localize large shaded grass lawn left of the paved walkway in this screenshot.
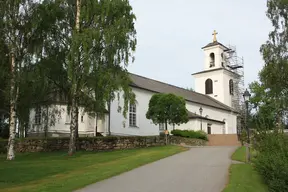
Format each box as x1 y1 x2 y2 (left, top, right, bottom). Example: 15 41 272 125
0 146 186 192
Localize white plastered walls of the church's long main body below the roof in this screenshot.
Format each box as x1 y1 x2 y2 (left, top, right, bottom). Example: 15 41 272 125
30 88 236 137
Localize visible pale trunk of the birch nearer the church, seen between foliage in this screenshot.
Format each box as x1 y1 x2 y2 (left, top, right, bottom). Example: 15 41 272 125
68 0 81 155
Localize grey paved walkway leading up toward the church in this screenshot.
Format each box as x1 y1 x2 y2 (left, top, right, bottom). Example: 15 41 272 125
77 147 237 192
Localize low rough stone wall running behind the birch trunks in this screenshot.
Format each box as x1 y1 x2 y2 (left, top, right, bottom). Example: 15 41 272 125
0 136 206 153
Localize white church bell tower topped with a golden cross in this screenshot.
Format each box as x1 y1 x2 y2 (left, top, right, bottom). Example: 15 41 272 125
192 31 239 108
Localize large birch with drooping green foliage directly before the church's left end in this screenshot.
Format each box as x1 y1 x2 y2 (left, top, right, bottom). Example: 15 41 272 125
36 0 136 154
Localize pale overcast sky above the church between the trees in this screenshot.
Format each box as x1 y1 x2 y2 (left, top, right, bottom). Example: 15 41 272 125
128 0 272 88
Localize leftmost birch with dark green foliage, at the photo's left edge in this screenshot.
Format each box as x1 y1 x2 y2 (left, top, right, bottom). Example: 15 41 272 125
0 0 69 159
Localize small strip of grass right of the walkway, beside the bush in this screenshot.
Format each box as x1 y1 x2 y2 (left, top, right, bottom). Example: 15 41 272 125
223 147 268 192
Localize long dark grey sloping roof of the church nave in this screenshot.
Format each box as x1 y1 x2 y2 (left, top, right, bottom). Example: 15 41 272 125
130 73 236 112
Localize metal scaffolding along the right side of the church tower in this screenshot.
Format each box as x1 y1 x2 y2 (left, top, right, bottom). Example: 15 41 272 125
224 45 245 134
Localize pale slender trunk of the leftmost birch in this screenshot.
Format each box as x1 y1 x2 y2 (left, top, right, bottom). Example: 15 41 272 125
7 53 16 160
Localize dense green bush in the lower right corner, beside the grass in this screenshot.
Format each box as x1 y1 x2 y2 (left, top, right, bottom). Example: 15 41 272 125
254 133 288 192
